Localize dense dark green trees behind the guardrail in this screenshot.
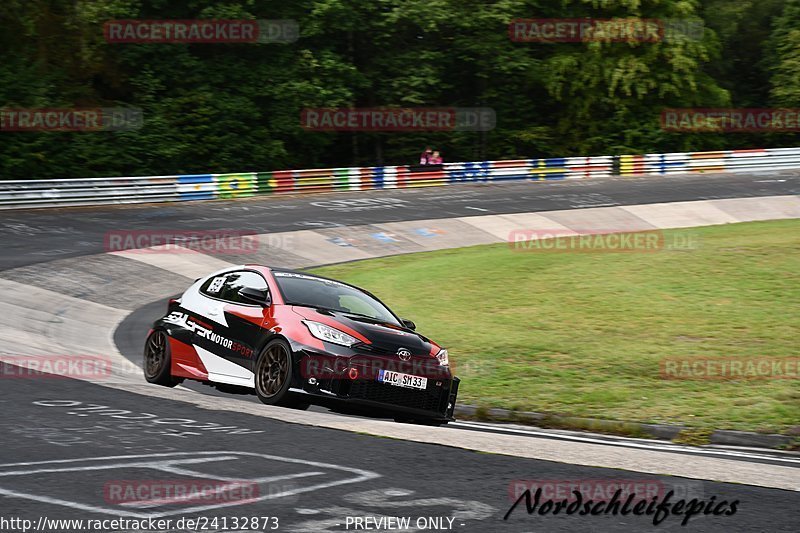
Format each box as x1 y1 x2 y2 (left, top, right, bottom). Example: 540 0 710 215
0 0 800 179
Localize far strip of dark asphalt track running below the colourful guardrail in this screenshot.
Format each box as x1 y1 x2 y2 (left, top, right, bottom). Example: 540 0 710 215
0 171 800 271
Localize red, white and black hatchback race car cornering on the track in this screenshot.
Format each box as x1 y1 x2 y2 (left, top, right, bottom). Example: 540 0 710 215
144 265 459 424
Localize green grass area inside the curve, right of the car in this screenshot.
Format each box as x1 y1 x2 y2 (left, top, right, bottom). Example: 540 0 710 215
315 220 800 432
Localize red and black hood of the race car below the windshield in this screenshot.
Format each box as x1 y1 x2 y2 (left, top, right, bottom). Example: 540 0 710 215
292 306 439 356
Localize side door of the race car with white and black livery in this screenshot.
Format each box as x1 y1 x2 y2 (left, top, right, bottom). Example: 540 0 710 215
195 270 268 386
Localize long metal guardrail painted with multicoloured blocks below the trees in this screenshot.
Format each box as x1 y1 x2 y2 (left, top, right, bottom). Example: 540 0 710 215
0 148 800 209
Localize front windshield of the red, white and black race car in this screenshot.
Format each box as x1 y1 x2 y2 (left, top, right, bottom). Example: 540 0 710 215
273 272 400 326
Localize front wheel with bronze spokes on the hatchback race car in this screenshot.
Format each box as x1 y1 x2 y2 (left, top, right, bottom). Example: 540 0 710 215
253 339 309 410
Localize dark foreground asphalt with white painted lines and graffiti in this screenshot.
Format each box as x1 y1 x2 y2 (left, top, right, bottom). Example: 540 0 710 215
0 362 797 532
